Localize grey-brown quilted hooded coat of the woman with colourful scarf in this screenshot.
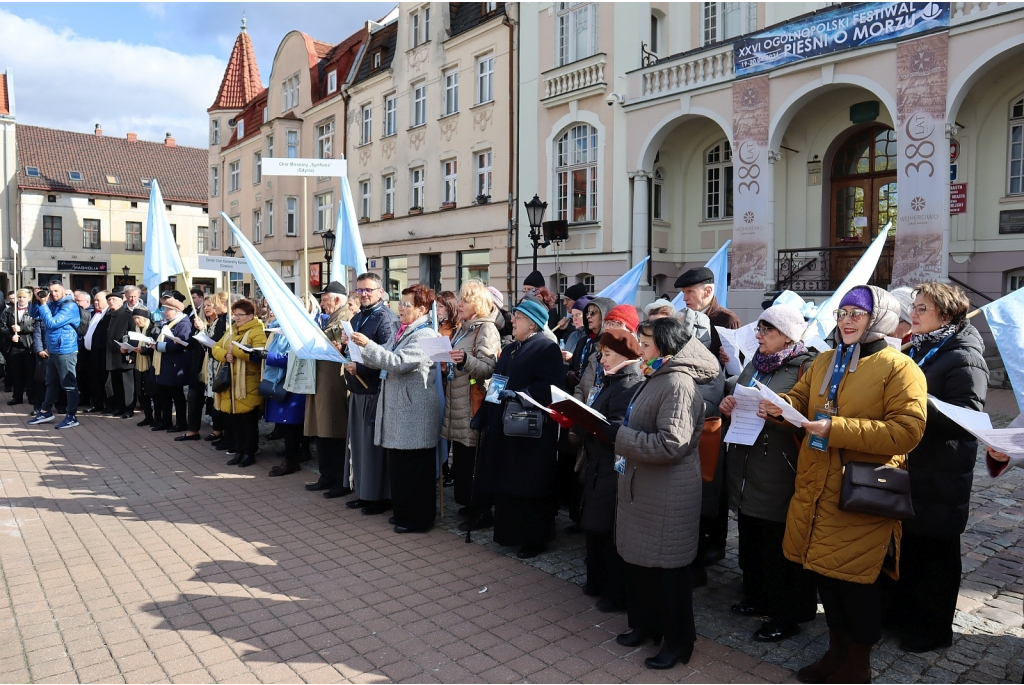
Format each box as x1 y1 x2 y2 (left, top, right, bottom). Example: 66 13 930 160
615 338 719 568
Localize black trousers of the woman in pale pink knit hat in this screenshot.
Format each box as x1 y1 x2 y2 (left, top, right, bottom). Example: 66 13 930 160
737 513 818 624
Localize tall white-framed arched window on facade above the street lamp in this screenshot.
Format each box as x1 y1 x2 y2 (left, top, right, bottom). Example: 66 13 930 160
555 124 597 223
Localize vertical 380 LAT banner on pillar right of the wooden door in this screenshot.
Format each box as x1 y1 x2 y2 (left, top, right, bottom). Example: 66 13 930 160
892 33 949 288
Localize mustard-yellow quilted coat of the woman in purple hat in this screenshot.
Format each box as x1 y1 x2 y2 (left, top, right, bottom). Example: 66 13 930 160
782 340 928 585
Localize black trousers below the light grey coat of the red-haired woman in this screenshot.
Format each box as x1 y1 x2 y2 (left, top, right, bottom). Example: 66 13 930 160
387 447 437 530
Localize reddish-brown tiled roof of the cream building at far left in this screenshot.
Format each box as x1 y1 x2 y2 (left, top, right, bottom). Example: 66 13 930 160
15 126 209 205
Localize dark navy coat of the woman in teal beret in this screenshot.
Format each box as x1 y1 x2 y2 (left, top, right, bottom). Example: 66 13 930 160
475 333 565 498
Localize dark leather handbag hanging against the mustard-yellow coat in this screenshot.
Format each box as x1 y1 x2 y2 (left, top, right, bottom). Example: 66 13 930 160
839 454 913 519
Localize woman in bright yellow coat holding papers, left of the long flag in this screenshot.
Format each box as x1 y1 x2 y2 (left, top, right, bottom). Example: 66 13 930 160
210 300 266 468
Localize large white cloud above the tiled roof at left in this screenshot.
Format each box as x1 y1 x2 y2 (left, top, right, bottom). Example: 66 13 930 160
0 9 225 147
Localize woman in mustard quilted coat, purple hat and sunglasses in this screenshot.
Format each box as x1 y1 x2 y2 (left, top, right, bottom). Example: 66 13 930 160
759 286 928 683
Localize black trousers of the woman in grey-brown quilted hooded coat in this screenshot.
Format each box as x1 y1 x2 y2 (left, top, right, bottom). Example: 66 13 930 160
626 564 697 649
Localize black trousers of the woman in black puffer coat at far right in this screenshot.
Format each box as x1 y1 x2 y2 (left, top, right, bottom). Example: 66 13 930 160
886 532 964 642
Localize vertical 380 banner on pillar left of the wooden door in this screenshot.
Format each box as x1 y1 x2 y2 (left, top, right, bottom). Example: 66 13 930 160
729 76 770 290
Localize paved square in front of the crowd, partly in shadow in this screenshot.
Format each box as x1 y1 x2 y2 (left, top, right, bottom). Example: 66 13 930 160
0 391 1024 682
